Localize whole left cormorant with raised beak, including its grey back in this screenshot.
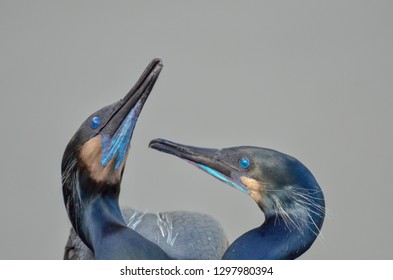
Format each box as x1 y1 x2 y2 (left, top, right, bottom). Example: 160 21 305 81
62 59 228 259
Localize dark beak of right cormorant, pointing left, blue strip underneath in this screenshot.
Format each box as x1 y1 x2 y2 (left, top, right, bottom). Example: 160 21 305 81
149 139 250 193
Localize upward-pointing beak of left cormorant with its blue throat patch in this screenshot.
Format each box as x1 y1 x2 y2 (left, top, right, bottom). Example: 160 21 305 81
99 58 163 169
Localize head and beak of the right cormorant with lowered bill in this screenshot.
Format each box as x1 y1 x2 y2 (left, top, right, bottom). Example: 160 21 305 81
149 139 325 233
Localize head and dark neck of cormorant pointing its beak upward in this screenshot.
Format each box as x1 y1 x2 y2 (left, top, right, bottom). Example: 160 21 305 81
62 59 169 259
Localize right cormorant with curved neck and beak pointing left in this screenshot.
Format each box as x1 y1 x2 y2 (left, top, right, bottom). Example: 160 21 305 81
150 139 325 259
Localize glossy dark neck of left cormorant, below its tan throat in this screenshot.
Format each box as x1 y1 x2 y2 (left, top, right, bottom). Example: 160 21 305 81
63 159 168 259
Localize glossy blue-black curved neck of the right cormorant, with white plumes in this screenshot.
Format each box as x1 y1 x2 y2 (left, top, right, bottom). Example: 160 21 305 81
223 187 325 259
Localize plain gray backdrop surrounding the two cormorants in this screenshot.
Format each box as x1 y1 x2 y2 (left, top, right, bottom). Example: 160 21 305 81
0 0 393 259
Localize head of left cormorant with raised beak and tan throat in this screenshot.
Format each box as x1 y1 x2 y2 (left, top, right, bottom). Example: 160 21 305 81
61 59 163 234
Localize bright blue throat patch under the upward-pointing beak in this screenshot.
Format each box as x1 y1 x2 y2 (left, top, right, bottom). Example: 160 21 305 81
101 100 143 170
